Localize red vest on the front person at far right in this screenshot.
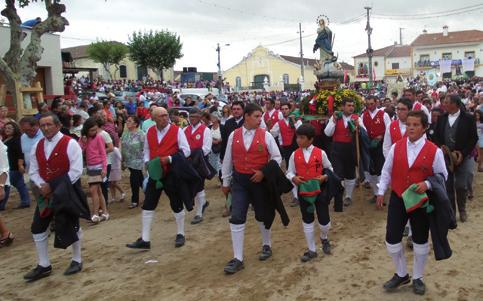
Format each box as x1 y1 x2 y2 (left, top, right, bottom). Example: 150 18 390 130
391 138 438 197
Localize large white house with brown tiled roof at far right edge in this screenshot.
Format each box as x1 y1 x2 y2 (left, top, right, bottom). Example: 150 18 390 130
411 26 483 80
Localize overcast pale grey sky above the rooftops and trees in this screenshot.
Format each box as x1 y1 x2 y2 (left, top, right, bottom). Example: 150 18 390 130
13 0 483 71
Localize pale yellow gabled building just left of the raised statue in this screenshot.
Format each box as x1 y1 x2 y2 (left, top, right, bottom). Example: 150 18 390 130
223 46 354 91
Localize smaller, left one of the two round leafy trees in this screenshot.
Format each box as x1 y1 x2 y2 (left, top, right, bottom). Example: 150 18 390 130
87 41 129 79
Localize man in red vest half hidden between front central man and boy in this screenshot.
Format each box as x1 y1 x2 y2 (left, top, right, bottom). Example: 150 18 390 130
270 102 302 206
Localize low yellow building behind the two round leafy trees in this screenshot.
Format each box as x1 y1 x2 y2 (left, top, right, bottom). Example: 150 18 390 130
62 45 174 81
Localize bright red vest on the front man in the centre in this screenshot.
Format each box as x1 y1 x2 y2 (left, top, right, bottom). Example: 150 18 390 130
231 128 269 174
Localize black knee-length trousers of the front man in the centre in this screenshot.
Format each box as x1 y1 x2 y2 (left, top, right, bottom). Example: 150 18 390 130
230 172 275 225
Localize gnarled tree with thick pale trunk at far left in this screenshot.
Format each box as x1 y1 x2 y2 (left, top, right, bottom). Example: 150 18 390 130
0 0 69 116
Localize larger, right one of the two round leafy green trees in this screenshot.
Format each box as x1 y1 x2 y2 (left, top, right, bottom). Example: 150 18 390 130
128 30 183 80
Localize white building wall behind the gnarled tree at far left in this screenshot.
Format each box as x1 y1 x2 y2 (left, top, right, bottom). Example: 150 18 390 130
0 25 64 95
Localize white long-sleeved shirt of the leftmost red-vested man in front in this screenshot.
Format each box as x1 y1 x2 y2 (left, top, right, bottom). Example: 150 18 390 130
29 132 83 187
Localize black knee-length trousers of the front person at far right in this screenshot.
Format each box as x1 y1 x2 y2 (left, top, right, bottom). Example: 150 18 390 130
386 192 429 245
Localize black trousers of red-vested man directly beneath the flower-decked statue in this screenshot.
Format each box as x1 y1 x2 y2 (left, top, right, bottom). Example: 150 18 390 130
330 142 356 180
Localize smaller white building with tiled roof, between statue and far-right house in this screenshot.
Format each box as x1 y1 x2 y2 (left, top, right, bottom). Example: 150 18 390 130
354 44 412 82
